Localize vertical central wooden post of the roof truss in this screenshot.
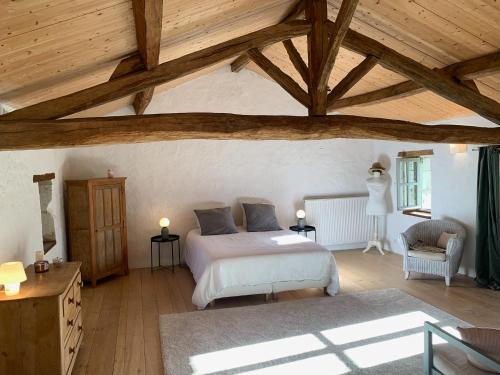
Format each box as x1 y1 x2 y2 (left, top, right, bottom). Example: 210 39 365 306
305 0 328 116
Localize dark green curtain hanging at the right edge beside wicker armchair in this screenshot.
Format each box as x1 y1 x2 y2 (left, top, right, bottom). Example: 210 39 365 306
476 146 500 290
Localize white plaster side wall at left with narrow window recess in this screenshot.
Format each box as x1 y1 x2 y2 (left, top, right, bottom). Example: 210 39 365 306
0 150 66 266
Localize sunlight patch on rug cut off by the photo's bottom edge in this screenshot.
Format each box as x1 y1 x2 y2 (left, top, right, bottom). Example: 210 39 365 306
239 354 351 375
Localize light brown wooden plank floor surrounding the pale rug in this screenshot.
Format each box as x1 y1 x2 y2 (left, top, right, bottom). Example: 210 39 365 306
77 250 500 375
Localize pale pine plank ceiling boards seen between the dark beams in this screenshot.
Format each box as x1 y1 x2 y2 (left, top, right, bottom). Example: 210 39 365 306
0 0 500 122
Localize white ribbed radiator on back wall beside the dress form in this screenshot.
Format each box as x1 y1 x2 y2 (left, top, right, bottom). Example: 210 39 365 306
304 196 373 250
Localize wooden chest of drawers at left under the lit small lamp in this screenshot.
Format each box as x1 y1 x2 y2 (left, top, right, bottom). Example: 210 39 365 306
0 262 83 375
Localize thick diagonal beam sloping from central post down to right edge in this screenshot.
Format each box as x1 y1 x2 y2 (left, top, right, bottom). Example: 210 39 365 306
340 27 500 125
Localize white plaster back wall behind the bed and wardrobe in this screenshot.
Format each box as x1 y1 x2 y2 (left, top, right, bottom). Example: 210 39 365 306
64 69 372 267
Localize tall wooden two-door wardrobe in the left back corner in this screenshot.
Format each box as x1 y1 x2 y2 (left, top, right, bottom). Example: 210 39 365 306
65 177 128 286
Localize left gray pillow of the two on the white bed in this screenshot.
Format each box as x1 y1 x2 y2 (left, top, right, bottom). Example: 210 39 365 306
194 207 238 236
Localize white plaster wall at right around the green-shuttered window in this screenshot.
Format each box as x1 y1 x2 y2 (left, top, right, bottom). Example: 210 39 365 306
373 116 495 276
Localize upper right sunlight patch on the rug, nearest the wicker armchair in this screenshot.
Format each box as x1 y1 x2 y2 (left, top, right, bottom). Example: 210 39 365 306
321 311 437 345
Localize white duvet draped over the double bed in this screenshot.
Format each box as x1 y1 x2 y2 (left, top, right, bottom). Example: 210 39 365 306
185 229 339 308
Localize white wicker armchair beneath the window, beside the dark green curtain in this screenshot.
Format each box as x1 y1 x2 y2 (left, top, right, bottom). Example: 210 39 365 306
399 220 465 286
